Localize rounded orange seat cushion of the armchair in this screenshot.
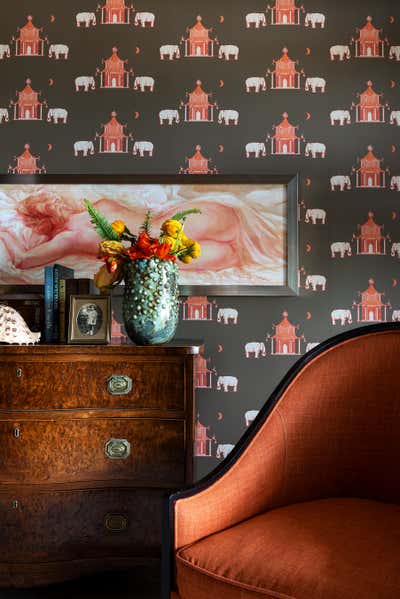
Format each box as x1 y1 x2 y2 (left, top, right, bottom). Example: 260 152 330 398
177 498 400 599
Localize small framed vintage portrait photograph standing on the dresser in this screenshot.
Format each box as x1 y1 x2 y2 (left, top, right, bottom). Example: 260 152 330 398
68 295 111 344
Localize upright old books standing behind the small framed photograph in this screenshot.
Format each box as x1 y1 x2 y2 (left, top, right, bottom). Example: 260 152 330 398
43 264 98 343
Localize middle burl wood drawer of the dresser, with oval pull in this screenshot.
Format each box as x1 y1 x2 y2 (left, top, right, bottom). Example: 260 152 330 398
0 418 185 486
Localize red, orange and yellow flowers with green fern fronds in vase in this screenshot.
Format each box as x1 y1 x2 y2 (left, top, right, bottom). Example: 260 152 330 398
84 200 201 291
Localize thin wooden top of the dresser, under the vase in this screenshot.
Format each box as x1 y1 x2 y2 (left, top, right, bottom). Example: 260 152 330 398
0 340 203 357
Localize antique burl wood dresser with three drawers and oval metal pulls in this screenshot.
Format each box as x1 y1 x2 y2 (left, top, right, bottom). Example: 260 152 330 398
0 345 198 587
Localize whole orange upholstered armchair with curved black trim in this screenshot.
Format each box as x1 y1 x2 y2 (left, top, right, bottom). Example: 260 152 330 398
163 323 400 599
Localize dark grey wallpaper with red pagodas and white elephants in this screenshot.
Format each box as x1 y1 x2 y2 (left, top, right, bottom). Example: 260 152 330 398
0 0 400 476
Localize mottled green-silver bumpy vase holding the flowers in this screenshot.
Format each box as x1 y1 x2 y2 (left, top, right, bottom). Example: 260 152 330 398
122 258 179 345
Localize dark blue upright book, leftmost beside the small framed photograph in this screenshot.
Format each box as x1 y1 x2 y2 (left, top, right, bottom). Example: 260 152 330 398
44 264 74 343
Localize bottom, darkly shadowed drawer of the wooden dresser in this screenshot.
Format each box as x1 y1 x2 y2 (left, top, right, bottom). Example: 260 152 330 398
0 489 163 563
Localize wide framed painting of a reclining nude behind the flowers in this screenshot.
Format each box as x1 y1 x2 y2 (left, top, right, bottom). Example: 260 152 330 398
0 175 298 296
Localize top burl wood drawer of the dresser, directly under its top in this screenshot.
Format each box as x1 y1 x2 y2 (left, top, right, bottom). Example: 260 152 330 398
0 356 185 410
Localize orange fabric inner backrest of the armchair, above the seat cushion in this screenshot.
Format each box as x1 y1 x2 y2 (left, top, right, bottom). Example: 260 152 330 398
174 330 400 549
